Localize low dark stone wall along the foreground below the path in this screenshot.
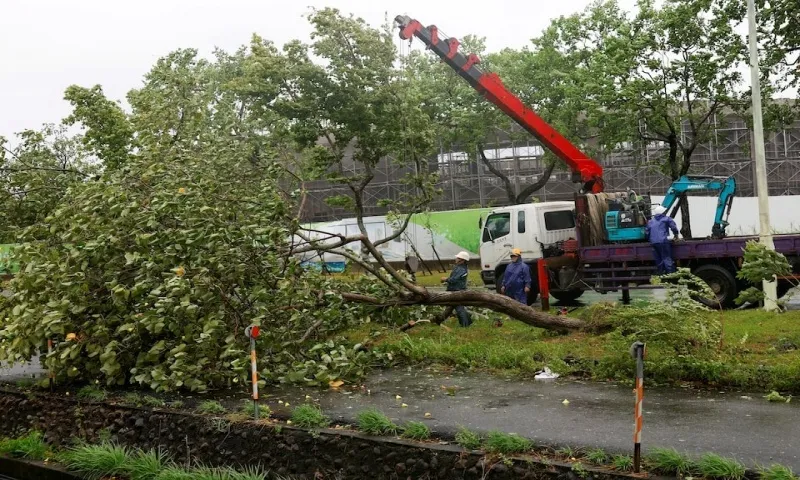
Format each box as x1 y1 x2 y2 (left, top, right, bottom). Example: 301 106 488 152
0 391 636 480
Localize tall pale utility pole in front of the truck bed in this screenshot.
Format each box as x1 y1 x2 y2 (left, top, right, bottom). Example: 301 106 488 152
747 0 778 311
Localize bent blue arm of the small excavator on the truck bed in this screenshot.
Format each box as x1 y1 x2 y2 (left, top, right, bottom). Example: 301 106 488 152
661 175 736 238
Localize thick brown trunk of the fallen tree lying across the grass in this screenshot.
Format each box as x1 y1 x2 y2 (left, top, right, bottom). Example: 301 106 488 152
342 290 586 330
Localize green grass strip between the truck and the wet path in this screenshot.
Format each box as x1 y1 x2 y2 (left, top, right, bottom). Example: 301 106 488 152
347 310 800 393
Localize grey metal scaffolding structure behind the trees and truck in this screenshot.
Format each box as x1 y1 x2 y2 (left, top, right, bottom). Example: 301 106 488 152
304 116 800 221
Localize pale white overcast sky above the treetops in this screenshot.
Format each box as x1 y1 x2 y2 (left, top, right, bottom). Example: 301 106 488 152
0 0 634 141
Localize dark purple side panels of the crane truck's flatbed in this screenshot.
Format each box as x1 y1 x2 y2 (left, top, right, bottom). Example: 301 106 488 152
580 234 800 264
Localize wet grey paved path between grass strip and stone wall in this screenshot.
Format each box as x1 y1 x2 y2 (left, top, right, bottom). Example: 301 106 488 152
269 371 800 471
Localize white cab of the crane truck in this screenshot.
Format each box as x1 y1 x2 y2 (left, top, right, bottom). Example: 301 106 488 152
480 202 575 285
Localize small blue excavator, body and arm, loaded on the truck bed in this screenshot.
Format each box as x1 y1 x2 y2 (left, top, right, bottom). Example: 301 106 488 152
605 175 736 242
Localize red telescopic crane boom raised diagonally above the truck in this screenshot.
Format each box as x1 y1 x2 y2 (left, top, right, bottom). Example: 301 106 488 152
395 15 603 193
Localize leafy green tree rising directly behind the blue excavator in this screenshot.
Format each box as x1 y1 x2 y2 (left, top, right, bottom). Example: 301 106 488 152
536 0 745 238
